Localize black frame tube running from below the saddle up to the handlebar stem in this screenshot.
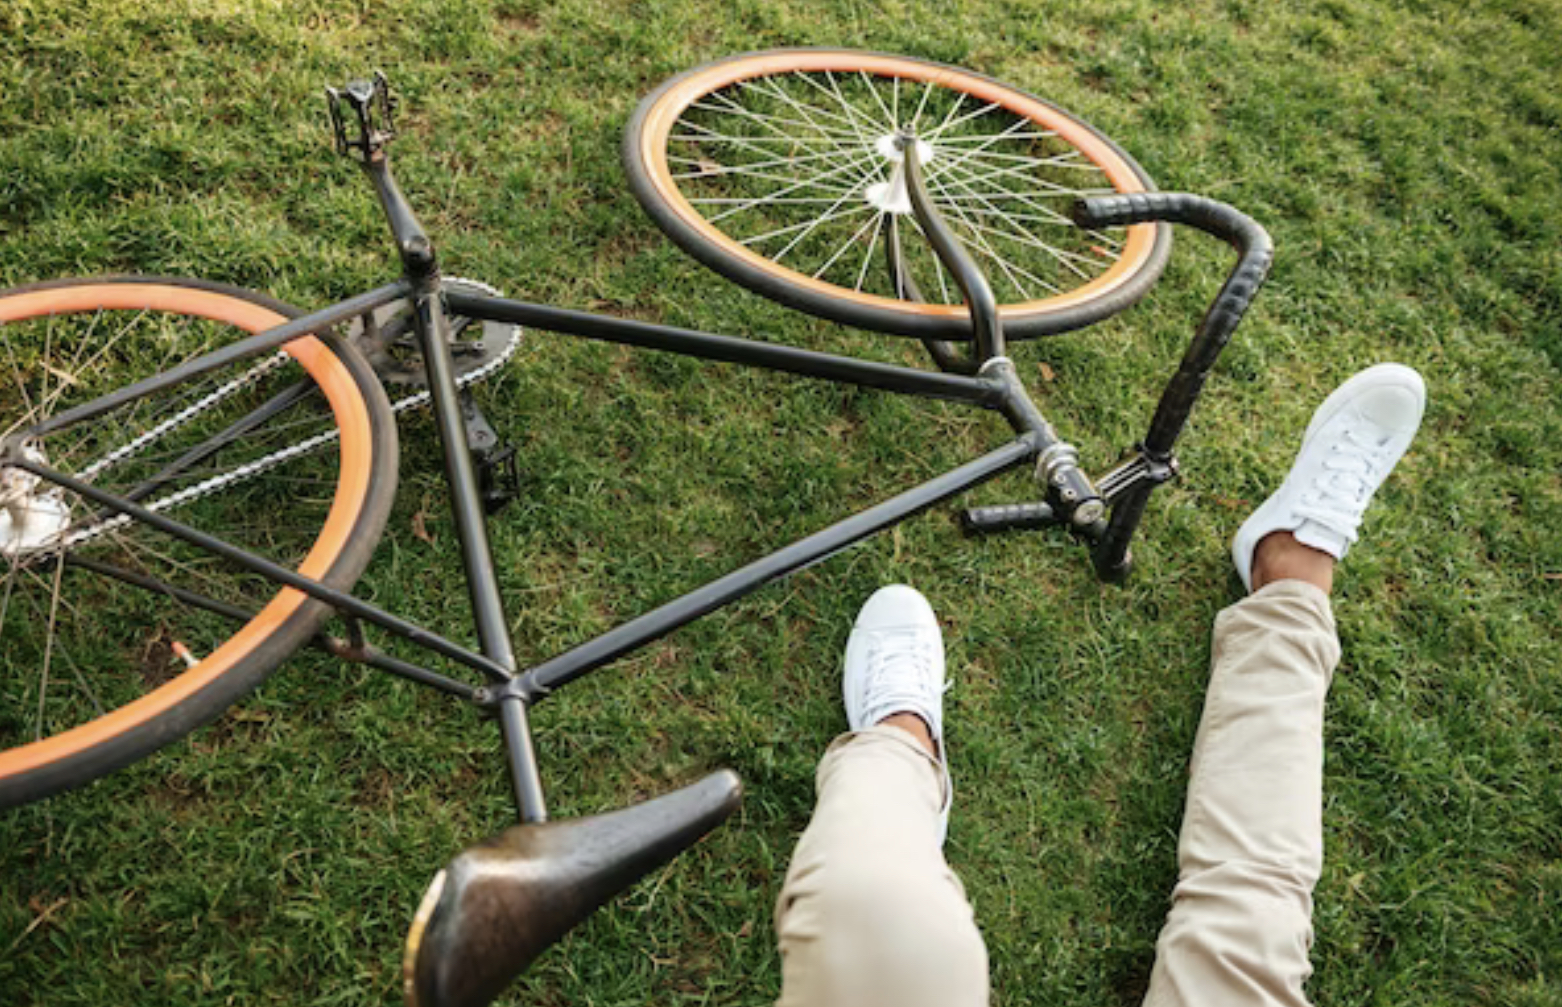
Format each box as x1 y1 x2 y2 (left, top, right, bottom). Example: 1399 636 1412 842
520 436 1036 698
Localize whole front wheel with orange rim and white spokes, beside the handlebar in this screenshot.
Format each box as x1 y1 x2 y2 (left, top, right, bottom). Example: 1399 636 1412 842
623 48 1172 339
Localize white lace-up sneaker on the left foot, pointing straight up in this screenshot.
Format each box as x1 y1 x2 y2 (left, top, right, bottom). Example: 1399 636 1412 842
840 584 954 843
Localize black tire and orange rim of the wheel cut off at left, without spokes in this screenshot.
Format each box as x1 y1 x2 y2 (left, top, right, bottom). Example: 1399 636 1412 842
0 276 398 807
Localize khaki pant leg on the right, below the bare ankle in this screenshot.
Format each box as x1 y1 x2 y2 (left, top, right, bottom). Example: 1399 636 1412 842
1145 581 1340 1007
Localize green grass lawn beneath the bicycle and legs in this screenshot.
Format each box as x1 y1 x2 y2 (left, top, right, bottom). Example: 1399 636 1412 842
0 0 1562 1007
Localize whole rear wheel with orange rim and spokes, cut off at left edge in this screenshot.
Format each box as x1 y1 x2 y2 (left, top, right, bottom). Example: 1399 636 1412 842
0 278 397 806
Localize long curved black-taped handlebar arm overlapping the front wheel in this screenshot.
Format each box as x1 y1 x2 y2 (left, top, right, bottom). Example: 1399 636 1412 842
1073 192 1275 457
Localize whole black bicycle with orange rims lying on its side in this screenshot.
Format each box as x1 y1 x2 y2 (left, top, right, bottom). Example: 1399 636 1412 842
0 50 1271 1007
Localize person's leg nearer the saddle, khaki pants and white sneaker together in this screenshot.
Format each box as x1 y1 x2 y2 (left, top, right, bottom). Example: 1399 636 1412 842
776 585 987 1007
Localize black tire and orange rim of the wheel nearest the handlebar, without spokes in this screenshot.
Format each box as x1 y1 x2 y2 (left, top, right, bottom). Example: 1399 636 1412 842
623 48 1172 340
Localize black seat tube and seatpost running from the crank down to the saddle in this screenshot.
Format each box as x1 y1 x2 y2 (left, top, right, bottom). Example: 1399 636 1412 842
412 283 548 821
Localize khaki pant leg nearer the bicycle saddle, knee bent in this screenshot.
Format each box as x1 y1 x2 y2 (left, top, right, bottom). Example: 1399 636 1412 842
776 724 987 1007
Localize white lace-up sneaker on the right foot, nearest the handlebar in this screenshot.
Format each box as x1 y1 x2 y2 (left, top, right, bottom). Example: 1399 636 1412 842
1231 364 1426 590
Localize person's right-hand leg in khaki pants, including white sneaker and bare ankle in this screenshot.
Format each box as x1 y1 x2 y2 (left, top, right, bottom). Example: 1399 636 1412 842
1145 365 1425 1007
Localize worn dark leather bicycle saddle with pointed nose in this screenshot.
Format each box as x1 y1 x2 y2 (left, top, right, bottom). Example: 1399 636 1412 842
403 770 742 1007
